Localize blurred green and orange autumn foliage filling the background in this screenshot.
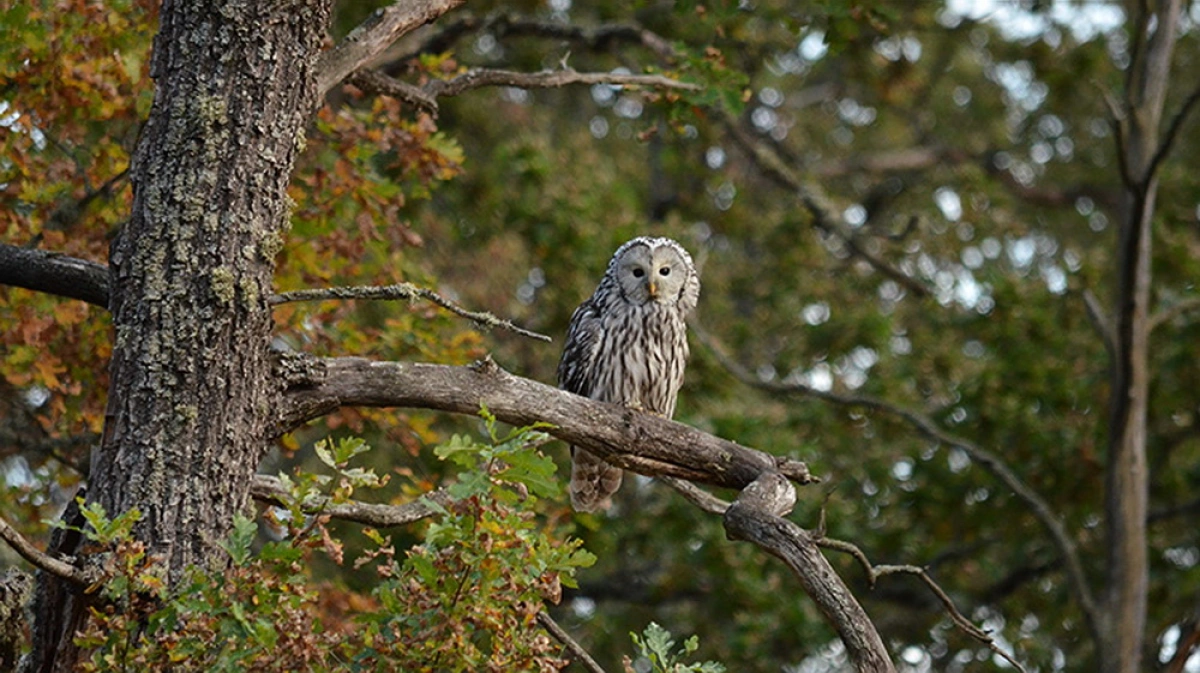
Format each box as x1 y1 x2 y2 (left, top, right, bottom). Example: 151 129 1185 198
0 0 1200 672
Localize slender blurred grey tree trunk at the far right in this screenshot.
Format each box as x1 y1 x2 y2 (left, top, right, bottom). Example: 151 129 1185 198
1098 0 1181 673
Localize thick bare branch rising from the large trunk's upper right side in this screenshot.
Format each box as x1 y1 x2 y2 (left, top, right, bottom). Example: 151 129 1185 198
317 0 464 98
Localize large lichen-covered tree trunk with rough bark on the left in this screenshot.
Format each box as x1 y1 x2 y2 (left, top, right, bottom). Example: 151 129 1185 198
29 0 330 672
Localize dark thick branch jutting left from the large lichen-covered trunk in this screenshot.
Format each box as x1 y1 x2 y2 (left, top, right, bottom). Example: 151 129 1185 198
0 244 108 308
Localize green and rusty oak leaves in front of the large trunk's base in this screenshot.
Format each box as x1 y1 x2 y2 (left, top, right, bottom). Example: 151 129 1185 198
68 422 595 672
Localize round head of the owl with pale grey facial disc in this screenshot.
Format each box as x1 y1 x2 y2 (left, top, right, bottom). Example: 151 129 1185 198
608 236 700 311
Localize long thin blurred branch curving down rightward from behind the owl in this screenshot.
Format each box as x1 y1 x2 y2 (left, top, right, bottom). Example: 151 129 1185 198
691 323 1100 633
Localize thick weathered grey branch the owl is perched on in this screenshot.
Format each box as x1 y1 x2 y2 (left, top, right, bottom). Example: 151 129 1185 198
275 357 816 488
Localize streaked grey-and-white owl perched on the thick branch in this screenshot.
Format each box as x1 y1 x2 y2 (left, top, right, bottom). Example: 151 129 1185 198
558 236 700 512
